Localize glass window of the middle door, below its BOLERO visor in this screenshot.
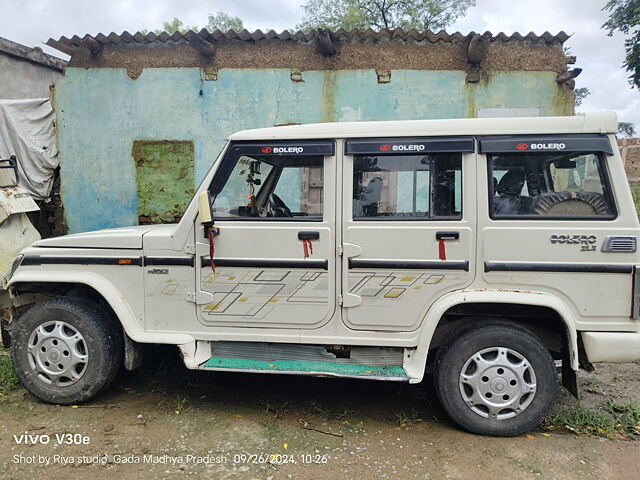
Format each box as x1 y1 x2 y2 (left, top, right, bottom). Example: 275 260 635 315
353 153 462 220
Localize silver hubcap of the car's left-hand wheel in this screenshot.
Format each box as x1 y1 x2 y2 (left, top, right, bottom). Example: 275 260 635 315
29 321 89 387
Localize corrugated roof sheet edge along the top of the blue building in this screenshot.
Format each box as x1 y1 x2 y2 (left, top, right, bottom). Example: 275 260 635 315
47 28 570 55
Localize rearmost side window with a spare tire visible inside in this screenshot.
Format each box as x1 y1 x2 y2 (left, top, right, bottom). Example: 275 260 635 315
489 152 616 220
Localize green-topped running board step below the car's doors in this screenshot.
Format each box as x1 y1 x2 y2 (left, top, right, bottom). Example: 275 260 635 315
201 357 409 382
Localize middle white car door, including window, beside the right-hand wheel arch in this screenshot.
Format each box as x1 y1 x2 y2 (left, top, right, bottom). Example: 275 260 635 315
342 137 476 331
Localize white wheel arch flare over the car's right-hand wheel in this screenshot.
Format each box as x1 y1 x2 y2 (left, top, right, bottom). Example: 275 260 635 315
404 290 578 383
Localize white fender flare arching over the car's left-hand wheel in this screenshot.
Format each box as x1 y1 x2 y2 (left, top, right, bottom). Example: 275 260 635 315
7 269 195 345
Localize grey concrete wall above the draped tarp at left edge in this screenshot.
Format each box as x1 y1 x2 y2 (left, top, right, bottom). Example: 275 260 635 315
0 52 62 99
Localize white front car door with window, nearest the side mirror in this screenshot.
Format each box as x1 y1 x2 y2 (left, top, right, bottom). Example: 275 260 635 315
195 141 336 328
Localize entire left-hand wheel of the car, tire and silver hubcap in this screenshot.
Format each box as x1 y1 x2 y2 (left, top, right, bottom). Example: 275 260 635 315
11 297 124 405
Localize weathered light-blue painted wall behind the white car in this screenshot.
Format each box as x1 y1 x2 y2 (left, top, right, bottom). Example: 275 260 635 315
54 68 573 233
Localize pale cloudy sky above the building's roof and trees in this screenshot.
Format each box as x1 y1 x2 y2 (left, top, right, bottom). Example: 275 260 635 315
0 0 640 127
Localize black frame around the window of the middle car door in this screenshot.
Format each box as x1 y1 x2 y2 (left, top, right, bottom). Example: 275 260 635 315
350 153 468 222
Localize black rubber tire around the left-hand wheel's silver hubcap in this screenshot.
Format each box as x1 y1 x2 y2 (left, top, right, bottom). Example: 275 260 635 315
11 297 124 405
